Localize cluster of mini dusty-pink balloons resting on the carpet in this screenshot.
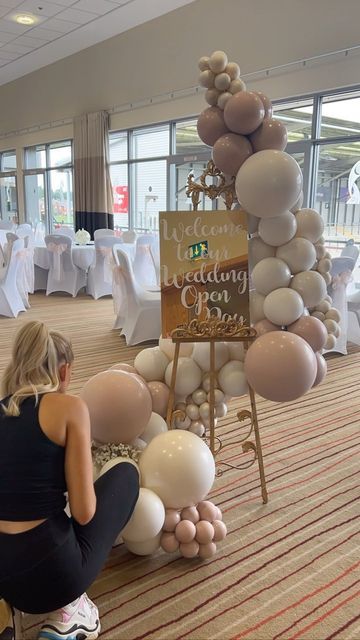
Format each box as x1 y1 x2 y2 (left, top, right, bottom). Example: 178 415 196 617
160 500 227 560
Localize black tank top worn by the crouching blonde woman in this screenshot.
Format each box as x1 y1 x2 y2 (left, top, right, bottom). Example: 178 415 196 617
0 397 66 522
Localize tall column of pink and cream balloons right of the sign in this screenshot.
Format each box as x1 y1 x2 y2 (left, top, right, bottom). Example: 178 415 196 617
197 51 340 402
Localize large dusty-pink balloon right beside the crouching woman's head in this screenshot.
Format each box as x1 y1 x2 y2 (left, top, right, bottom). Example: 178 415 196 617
80 370 152 444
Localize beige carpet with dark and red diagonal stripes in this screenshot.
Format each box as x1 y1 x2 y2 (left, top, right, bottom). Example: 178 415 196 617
0 295 360 640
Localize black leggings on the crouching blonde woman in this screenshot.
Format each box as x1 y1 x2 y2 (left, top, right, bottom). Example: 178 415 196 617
0 462 139 613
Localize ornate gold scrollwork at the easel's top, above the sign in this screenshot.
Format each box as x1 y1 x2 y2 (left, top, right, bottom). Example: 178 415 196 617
185 160 237 211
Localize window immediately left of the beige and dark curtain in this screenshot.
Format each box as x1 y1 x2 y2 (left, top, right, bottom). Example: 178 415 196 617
24 141 74 231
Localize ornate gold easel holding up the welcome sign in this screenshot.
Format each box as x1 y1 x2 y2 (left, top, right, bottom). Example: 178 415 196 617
166 160 268 504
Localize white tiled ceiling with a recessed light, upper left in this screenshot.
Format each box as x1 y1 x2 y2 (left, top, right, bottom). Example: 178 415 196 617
0 0 193 85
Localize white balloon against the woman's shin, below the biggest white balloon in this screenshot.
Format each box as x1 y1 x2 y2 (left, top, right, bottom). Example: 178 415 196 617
121 488 165 542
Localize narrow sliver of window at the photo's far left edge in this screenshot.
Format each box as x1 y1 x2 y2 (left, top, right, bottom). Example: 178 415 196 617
0 151 18 222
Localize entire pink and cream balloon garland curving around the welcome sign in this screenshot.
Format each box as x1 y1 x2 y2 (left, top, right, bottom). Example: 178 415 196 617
81 51 340 559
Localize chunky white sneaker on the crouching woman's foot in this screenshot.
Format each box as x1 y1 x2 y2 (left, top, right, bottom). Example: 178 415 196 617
38 593 100 640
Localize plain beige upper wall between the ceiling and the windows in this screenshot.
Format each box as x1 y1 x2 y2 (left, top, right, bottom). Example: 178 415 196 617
0 0 360 218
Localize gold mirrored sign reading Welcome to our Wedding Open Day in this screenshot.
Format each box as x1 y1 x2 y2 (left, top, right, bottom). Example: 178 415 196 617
160 209 250 337
